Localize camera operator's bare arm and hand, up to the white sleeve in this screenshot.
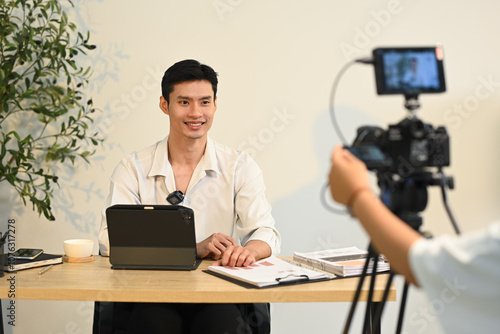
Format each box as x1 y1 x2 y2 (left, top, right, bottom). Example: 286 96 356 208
329 146 421 284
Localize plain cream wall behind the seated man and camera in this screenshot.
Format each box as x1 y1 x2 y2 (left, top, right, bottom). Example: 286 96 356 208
0 0 500 334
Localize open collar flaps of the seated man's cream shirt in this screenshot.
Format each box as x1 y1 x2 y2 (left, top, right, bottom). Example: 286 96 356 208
148 136 220 177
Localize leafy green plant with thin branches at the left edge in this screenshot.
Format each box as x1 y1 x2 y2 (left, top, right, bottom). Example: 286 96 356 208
0 0 102 220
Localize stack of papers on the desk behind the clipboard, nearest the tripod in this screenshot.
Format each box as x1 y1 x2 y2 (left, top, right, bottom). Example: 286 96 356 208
293 247 390 277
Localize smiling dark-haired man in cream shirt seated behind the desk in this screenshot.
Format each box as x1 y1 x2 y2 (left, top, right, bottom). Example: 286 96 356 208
99 60 281 333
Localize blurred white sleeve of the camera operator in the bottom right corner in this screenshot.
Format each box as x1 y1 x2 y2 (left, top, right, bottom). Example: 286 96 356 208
409 223 500 333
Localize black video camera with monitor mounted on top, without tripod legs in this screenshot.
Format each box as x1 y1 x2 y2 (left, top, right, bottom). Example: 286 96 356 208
346 47 453 222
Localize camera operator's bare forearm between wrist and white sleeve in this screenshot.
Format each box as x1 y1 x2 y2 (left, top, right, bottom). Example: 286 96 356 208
352 191 421 284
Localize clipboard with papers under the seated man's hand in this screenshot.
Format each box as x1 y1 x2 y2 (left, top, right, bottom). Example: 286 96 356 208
207 256 331 288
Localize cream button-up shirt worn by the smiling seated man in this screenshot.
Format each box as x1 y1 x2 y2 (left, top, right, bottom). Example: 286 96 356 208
99 137 281 256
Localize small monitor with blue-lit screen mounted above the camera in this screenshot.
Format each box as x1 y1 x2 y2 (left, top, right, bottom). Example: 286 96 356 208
373 47 446 95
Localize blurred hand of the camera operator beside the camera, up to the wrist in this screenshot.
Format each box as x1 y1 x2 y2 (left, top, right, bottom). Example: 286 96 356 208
329 145 370 206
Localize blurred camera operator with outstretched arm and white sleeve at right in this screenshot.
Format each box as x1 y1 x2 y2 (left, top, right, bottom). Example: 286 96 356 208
329 146 500 334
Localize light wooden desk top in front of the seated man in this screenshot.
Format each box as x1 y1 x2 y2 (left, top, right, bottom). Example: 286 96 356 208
0 256 396 303
